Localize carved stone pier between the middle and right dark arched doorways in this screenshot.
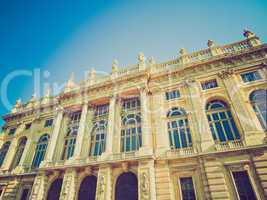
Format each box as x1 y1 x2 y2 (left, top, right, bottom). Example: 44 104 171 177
95 165 112 200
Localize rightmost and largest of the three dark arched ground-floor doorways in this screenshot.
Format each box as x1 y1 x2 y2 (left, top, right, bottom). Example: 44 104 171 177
115 172 138 200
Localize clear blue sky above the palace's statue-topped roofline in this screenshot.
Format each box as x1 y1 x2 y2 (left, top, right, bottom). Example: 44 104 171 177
0 0 267 126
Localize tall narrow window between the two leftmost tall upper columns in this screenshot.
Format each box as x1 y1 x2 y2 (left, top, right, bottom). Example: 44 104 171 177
61 111 81 160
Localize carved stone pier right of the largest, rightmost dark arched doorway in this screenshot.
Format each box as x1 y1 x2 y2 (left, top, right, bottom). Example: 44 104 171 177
138 160 156 200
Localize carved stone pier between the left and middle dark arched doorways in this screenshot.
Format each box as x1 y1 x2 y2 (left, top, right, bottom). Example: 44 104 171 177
59 168 78 200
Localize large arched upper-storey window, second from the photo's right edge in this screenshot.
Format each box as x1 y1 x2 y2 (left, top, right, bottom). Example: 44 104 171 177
206 100 240 143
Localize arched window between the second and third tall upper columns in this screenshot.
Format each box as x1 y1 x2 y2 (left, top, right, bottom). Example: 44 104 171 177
90 120 107 156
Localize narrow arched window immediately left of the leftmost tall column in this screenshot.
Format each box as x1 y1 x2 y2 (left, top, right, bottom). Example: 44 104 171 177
32 134 49 168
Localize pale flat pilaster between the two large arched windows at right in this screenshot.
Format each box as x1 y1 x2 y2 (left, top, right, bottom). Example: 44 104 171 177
184 80 214 151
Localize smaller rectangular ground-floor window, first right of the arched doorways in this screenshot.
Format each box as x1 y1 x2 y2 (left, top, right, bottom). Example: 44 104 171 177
180 177 196 200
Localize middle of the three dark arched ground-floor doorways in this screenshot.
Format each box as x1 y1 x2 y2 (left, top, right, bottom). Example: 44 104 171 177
78 176 97 200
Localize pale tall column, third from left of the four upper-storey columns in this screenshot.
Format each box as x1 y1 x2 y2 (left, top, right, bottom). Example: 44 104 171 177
102 95 116 157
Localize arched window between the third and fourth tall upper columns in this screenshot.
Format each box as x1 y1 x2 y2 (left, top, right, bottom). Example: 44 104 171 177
121 114 142 152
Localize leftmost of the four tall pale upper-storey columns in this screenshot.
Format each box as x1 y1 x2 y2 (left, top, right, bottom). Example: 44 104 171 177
45 108 64 163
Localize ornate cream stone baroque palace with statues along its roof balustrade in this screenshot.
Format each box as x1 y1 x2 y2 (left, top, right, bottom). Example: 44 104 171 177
0 30 267 200
